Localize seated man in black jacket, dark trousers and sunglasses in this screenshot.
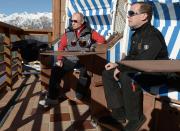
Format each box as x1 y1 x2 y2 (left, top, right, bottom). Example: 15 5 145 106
102 2 168 131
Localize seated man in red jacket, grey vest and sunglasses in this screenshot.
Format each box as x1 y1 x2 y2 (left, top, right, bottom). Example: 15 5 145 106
39 12 105 107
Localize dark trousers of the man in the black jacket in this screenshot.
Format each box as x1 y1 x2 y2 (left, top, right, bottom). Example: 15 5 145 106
102 69 165 120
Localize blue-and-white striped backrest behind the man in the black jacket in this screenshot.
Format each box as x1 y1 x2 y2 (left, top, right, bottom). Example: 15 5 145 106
107 0 180 62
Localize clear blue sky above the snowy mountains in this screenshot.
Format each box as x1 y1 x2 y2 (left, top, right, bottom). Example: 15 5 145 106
0 0 52 15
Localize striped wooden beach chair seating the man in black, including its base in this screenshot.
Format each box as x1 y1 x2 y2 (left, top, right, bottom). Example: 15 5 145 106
92 0 180 131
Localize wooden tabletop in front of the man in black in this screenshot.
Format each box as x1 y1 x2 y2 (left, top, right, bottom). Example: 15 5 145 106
120 60 180 72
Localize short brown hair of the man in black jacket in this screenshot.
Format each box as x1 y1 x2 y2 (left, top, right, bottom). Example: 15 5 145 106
132 2 152 21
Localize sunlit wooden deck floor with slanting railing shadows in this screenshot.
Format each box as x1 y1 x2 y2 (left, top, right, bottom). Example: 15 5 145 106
0 75 107 131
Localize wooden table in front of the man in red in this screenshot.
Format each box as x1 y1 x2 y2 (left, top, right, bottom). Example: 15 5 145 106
40 51 106 74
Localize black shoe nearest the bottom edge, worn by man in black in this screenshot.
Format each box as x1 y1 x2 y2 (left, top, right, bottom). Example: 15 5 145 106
124 115 146 131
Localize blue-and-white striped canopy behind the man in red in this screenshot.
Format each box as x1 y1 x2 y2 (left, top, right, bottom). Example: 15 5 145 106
66 0 117 38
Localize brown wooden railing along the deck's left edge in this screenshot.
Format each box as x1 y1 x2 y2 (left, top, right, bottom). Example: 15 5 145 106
0 22 52 89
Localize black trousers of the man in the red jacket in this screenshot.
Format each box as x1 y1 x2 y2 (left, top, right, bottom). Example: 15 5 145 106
48 59 87 99
